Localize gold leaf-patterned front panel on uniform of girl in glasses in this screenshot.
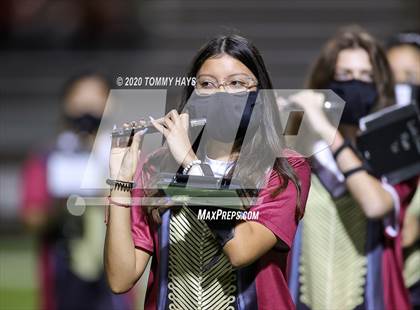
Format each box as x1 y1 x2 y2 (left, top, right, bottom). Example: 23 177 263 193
168 206 236 310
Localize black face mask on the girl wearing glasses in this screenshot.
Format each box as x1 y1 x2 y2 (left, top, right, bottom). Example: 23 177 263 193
188 91 262 143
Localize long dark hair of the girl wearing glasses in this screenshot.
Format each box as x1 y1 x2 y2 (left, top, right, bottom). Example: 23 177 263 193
144 35 303 220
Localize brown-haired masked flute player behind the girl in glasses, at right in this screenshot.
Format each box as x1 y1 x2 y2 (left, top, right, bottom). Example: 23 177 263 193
289 26 417 309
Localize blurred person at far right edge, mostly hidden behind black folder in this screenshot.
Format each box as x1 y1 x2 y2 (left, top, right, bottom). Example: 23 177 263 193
387 32 420 308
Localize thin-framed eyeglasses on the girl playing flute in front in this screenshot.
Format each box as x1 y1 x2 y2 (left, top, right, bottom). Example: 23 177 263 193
195 74 258 96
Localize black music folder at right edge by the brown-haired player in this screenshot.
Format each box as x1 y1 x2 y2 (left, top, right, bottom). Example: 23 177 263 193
357 104 420 184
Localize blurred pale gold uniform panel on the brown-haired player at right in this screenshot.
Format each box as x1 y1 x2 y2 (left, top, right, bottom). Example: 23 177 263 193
299 175 367 310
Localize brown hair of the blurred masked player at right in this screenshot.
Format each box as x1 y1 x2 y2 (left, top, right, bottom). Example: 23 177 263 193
306 25 394 110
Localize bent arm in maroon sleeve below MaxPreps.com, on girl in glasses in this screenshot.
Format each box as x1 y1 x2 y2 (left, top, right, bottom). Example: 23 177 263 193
223 158 310 268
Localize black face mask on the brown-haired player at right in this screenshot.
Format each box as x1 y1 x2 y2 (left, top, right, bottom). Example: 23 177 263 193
328 80 378 126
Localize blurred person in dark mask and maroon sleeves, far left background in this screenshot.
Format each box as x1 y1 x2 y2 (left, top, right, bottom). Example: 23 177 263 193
22 72 131 310
